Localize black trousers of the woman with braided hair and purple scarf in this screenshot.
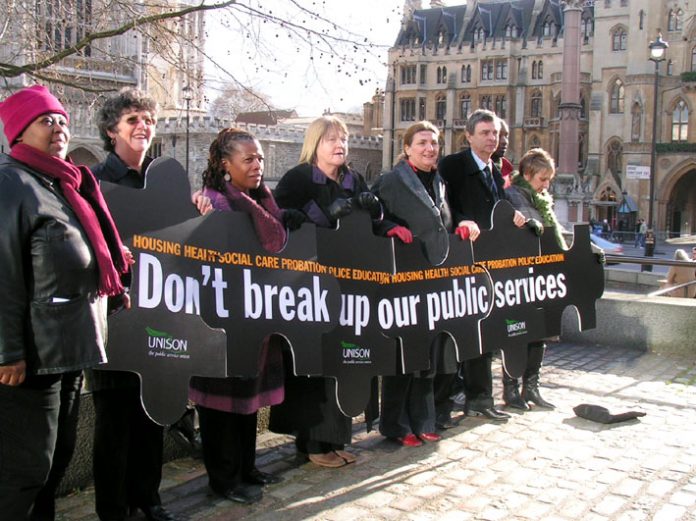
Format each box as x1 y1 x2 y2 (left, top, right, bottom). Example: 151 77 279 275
196 405 257 494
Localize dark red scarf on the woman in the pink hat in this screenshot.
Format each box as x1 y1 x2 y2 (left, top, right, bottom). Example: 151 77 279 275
10 143 128 296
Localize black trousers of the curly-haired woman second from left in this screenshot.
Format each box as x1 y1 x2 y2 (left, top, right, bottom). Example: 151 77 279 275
92 387 164 520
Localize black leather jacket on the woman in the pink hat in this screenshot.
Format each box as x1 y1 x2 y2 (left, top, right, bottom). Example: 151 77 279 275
0 154 106 374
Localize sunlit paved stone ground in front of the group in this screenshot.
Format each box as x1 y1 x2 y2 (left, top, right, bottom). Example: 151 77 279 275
59 343 696 521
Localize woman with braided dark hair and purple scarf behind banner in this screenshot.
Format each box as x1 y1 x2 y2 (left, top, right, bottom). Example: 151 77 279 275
189 128 287 503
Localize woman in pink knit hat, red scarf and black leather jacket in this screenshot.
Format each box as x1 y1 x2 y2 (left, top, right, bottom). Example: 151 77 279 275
0 85 132 520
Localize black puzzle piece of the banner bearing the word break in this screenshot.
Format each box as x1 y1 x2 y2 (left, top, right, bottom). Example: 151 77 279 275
187 212 340 377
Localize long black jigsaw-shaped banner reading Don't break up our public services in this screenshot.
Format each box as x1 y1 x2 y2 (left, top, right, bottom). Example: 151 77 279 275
102 159 603 424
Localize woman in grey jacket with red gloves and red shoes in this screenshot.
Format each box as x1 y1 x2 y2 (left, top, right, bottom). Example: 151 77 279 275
372 121 455 447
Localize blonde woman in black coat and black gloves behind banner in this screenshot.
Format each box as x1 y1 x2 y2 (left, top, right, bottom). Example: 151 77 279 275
270 116 381 468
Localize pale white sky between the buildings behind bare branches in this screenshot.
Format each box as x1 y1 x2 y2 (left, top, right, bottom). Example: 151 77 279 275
206 0 406 116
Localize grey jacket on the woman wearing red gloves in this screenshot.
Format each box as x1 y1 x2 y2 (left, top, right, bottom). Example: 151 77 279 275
372 160 452 265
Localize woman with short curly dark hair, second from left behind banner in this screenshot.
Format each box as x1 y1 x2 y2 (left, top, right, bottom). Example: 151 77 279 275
88 89 196 521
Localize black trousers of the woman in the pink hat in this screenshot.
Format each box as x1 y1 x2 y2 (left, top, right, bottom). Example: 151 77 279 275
0 371 82 521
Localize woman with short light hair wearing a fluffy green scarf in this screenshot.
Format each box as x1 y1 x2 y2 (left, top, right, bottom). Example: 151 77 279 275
503 148 567 410
